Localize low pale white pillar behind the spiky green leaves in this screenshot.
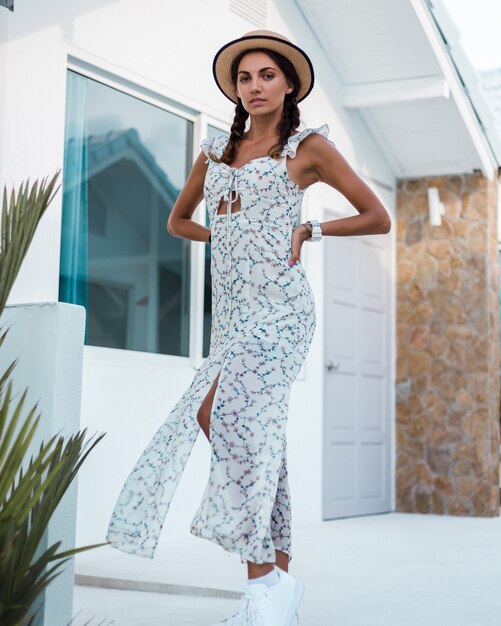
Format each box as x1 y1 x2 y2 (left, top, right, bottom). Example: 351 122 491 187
0 302 88 626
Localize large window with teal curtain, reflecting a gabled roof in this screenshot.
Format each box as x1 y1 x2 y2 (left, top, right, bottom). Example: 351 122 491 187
59 70 191 356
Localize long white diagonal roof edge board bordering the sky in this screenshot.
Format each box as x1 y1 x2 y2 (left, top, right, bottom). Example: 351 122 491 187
410 0 498 180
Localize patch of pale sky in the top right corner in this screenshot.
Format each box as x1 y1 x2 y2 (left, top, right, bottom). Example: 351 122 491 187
442 0 501 70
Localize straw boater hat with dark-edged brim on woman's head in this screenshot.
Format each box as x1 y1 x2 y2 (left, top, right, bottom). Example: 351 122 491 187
212 30 315 104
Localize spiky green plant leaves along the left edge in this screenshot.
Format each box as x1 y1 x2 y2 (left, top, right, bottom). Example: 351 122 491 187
0 170 107 626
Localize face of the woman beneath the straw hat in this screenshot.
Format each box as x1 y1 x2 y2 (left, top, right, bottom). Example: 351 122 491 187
237 52 292 115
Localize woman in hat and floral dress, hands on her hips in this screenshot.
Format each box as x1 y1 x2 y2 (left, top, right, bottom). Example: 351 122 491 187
107 31 391 626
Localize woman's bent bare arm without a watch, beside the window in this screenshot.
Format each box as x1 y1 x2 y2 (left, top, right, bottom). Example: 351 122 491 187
167 152 210 241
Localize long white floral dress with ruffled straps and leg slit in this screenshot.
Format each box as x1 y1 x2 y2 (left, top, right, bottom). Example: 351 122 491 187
106 124 329 563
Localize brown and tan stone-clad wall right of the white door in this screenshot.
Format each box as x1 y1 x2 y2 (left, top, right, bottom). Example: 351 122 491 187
396 174 500 516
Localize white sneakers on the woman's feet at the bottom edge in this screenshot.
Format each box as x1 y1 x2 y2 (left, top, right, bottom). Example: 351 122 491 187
213 567 304 626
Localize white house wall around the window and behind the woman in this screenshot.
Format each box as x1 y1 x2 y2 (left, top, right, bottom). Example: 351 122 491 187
0 0 394 572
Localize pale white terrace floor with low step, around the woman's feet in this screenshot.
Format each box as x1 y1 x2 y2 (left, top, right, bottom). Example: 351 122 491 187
72 513 501 626
